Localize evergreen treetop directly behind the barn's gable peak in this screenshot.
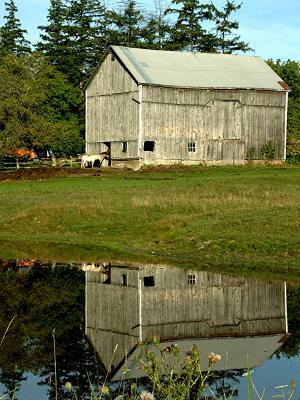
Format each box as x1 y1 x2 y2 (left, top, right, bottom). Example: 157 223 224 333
110 0 147 47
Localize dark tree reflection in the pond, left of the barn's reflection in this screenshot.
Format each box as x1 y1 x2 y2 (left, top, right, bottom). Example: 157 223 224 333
0 262 102 399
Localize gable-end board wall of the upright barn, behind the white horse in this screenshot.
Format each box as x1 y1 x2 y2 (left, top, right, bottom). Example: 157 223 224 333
86 54 139 159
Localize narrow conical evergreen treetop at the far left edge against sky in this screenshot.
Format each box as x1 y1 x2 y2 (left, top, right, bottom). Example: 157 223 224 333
0 0 31 56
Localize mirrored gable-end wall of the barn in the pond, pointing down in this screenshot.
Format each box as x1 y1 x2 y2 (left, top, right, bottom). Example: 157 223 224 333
85 271 139 369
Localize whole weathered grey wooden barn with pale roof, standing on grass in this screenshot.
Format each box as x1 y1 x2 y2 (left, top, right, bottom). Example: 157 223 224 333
86 46 289 168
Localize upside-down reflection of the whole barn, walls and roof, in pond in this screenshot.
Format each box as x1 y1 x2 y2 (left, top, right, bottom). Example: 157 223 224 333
86 265 288 380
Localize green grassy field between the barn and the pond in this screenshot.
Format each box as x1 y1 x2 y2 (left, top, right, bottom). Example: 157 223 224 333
0 166 300 280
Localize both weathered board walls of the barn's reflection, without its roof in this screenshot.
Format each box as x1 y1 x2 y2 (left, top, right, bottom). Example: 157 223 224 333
86 265 287 376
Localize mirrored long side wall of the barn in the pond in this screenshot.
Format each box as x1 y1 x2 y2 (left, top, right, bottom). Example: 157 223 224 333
142 268 285 340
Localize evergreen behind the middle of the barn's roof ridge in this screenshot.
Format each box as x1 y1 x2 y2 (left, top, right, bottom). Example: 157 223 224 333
166 0 216 52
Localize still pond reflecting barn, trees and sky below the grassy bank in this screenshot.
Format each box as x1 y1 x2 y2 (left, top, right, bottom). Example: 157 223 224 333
0 260 300 400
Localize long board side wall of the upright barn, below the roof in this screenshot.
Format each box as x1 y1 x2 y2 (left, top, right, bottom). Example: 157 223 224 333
143 86 285 163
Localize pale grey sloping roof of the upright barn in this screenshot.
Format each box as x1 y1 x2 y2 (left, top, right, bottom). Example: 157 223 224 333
111 46 289 91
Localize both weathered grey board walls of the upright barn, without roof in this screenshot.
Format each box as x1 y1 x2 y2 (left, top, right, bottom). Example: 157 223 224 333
86 47 286 166
